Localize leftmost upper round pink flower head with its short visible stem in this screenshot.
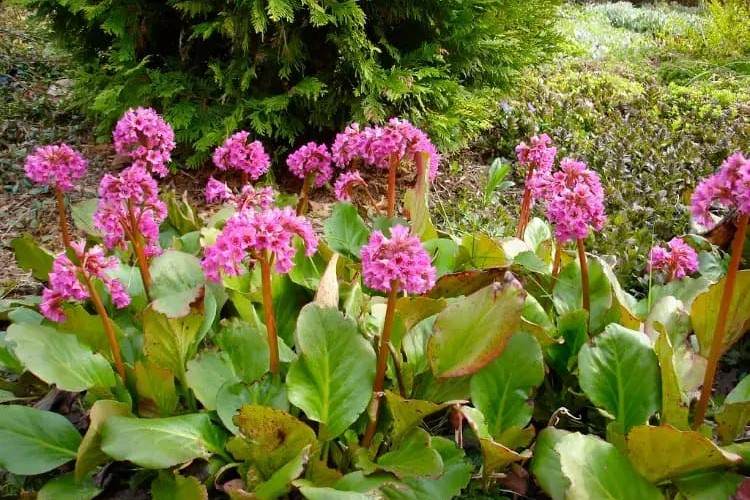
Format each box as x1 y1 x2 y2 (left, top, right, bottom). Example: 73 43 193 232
25 144 87 248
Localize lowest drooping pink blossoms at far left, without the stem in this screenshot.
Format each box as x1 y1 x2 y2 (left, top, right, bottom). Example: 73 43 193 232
39 241 130 322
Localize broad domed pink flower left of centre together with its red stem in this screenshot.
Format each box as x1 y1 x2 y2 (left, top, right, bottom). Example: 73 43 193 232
201 207 318 374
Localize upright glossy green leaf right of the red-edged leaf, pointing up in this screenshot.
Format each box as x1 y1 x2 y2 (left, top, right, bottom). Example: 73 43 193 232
578 324 661 442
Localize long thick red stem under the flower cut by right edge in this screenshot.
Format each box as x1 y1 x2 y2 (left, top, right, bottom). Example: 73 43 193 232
693 215 748 429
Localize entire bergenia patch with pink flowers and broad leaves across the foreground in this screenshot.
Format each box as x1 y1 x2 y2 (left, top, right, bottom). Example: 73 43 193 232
0 108 750 499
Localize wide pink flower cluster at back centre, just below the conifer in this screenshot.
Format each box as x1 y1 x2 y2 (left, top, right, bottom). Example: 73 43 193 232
331 118 440 181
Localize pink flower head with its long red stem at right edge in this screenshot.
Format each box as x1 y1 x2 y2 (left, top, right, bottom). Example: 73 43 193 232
692 152 750 428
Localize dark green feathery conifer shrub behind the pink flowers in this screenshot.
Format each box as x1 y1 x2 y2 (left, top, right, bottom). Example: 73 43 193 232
24 0 559 162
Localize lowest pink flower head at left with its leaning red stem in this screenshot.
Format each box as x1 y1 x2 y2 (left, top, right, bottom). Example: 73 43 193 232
39 241 130 380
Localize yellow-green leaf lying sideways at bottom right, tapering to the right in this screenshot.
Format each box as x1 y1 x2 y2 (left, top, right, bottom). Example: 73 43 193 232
628 425 742 483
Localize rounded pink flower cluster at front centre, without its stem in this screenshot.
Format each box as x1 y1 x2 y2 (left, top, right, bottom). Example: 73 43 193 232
361 225 436 294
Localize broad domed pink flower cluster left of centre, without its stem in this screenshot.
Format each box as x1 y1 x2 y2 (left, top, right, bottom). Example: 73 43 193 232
201 207 318 281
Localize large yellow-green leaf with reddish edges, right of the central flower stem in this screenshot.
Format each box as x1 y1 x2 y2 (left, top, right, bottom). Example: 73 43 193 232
427 273 526 378
